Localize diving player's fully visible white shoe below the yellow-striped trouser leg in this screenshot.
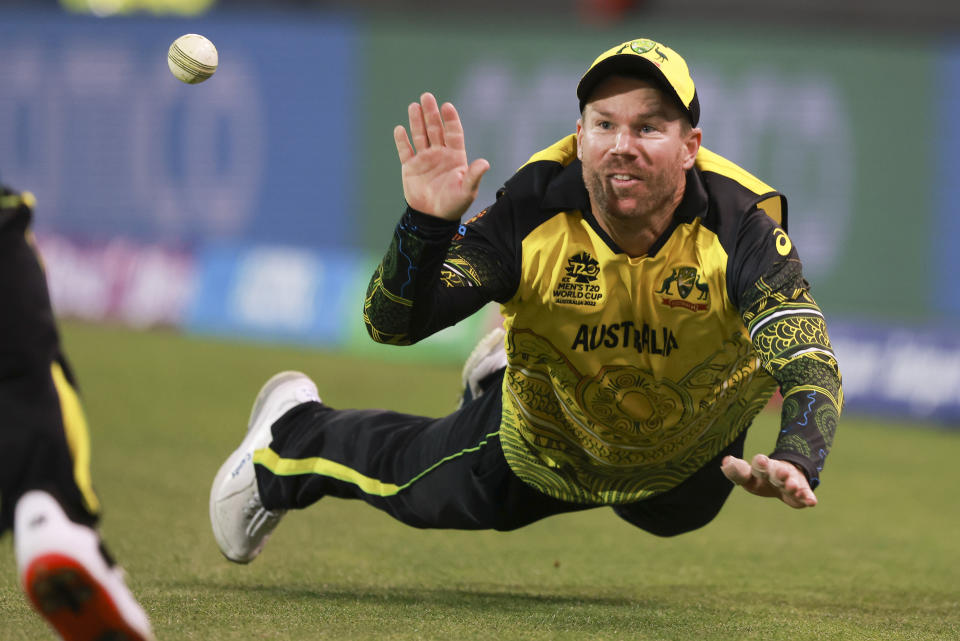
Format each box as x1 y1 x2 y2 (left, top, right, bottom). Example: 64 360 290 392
210 372 320 563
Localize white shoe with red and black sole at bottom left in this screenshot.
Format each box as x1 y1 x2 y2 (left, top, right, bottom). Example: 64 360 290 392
13 490 154 641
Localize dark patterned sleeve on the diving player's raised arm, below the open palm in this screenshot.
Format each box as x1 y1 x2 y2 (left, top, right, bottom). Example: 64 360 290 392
363 210 516 345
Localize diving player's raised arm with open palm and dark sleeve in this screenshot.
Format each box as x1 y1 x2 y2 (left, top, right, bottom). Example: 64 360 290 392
363 93 510 345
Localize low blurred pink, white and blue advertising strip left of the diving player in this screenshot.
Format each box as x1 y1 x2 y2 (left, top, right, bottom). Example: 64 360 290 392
37 234 499 363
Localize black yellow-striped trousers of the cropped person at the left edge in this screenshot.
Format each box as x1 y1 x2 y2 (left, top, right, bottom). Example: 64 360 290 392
0 188 98 534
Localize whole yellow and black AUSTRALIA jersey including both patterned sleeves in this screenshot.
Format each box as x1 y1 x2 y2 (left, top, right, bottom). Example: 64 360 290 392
367 136 842 504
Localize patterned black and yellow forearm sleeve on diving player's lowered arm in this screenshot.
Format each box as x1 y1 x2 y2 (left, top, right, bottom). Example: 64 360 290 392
741 259 843 487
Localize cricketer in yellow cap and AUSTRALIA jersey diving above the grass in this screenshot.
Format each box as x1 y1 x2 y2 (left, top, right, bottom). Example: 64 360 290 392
210 39 842 562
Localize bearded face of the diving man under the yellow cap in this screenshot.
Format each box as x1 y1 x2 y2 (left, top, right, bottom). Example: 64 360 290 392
577 76 700 222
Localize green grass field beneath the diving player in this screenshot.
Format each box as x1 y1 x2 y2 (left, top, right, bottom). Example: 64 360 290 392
0 324 960 641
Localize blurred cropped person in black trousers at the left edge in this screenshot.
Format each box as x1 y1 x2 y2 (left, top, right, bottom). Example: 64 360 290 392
0 186 154 641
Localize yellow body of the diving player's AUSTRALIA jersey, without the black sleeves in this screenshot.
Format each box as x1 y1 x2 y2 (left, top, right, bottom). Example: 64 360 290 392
492 138 776 503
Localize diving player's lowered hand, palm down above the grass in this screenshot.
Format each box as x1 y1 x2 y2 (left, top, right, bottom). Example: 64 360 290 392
720 454 817 508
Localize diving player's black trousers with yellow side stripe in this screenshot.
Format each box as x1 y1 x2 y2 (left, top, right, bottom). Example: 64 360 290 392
254 371 746 536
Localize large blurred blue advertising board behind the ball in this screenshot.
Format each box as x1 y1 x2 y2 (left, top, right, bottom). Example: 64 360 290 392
0 13 358 247
